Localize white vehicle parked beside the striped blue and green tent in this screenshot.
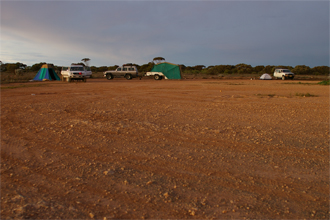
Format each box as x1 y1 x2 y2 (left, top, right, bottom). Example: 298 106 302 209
61 64 92 82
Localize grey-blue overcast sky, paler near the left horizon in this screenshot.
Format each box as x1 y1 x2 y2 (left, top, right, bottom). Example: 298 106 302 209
0 0 329 67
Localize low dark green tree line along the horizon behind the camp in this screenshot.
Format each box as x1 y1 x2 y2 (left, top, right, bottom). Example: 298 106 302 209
0 58 330 75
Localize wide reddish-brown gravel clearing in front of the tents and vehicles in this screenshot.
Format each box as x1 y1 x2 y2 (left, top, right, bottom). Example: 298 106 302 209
1 79 329 219
